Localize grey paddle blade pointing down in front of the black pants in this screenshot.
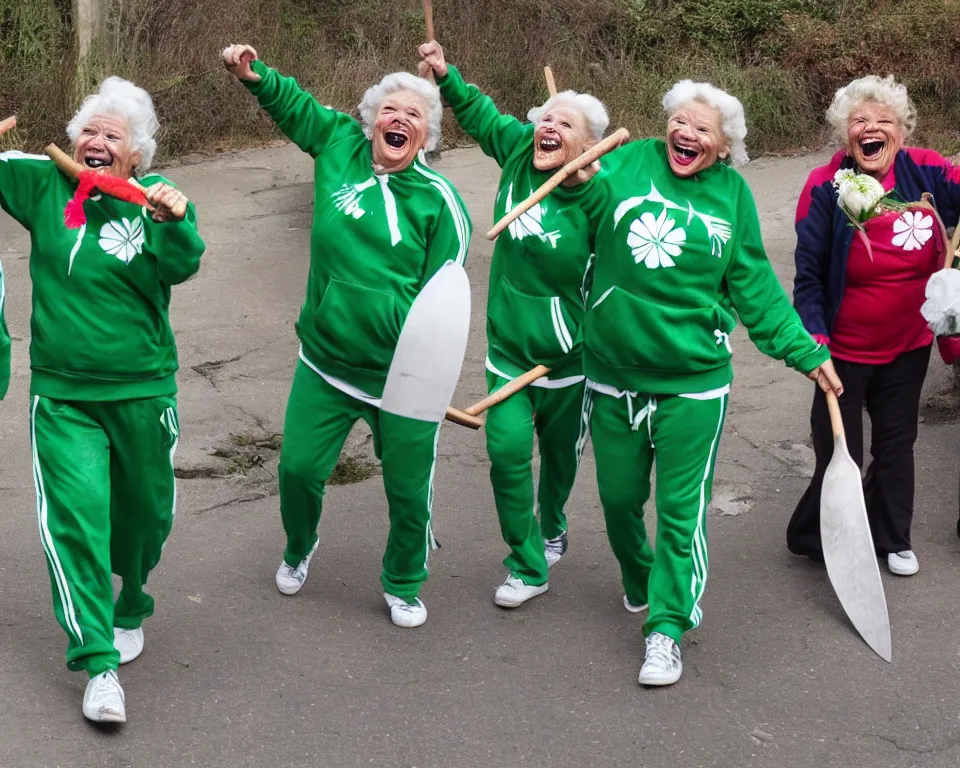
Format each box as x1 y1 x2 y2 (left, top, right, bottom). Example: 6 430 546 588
820 434 892 661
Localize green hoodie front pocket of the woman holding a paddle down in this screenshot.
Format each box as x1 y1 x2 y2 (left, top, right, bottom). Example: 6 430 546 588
584 287 735 373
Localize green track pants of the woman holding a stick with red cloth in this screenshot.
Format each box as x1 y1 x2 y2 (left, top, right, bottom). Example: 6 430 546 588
30 395 180 677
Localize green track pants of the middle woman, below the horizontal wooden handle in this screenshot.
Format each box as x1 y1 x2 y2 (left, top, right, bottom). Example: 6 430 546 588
484 371 584 586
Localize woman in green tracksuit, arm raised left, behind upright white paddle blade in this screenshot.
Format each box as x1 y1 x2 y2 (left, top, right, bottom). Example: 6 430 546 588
223 45 470 627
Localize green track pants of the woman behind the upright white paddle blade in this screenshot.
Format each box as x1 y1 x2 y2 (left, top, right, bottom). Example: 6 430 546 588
280 361 439 602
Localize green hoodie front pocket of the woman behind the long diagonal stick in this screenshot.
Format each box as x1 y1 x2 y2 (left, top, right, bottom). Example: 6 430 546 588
487 280 579 365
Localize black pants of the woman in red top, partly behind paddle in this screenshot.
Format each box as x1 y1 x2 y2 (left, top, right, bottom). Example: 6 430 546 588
787 346 930 562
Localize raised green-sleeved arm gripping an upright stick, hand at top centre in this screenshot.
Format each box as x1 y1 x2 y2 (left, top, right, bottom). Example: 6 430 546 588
420 41 533 167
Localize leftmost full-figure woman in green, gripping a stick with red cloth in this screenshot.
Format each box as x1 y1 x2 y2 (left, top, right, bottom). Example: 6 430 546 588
0 77 205 722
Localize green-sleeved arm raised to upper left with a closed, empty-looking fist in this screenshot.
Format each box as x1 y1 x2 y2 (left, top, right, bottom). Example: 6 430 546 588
222 45 361 157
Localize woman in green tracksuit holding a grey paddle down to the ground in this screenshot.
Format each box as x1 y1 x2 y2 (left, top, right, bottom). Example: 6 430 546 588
584 80 840 685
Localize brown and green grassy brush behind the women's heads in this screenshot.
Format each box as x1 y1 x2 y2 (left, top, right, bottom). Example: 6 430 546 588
0 0 960 161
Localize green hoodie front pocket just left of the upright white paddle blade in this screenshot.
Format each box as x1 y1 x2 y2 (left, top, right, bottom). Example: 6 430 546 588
313 279 403 372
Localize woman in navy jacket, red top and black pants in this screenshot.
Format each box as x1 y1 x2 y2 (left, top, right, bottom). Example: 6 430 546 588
787 75 960 576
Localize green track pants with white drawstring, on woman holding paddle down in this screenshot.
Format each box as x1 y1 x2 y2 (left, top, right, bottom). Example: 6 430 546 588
586 390 727 643
